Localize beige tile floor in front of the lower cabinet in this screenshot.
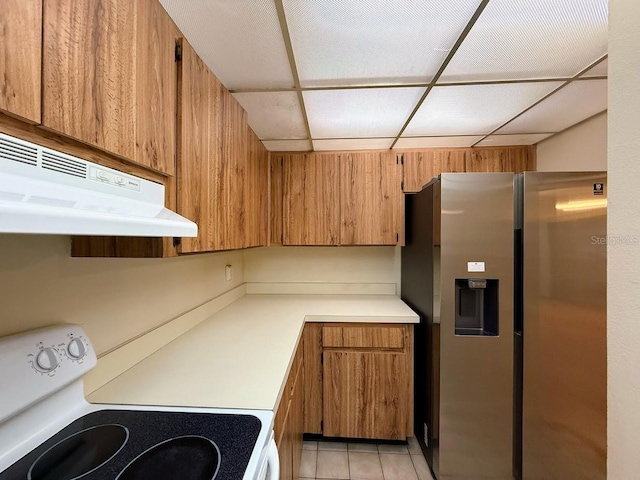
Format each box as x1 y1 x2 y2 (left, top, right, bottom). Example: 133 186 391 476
299 438 433 480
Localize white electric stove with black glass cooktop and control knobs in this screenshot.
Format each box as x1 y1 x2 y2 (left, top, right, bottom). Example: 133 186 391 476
0 325 279 480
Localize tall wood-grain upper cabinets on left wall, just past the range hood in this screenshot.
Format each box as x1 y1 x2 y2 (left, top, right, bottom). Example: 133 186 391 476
177 40 269 253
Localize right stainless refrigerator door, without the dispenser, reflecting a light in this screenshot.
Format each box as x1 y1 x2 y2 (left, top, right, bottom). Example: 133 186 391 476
516 172 608 480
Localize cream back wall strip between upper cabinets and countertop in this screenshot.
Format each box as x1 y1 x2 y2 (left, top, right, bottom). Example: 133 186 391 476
244 247 400 285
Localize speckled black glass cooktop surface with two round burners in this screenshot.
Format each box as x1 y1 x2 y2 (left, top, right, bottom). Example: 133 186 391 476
0 410 261 480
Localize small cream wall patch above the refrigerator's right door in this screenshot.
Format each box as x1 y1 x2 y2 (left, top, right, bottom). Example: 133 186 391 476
537 112 607 172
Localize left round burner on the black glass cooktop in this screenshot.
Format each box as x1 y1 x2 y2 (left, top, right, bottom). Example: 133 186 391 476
27 424 129 480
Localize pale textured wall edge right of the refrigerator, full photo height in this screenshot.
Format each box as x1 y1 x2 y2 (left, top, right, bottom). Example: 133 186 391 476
607 0 640 480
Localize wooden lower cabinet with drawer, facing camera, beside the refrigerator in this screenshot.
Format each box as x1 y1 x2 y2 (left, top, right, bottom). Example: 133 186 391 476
303 323 413 440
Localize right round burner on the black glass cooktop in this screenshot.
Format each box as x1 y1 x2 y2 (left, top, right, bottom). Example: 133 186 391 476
116 435 220 480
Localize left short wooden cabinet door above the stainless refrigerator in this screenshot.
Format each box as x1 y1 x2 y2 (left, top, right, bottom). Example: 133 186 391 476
402 149 465 193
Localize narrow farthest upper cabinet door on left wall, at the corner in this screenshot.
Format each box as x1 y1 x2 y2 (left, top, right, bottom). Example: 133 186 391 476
244 126 269 247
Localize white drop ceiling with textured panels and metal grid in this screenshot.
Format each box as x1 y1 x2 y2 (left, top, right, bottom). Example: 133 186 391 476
160 0 608 151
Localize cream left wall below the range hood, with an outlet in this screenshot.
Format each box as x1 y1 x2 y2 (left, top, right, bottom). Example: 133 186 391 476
0 235 243 353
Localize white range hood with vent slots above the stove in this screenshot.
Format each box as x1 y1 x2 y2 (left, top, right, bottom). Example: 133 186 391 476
0 134 198 237
